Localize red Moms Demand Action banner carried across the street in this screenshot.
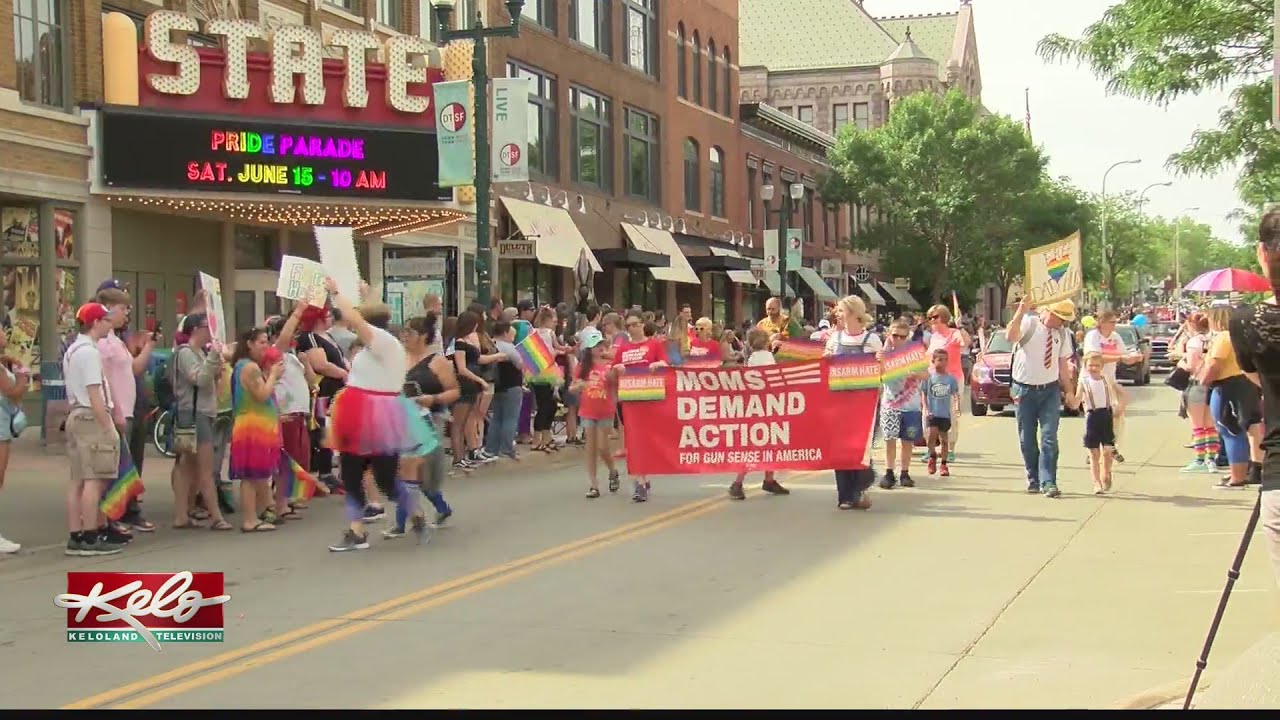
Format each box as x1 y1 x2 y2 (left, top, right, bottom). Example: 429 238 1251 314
618 360 879 475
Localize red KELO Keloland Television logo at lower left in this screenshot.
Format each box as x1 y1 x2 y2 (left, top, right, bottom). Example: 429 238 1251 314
54 570 232 652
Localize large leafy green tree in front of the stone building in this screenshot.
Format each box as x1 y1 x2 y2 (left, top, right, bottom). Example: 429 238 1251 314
823 91 1046 300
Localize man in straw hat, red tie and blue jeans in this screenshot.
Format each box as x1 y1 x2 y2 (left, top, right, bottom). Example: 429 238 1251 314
1005 297 1075 497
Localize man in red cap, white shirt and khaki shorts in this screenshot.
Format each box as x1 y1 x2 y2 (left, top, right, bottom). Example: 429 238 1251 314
63 302 124 556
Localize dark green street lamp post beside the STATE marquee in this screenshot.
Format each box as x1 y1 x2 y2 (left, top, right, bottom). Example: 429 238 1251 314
433 0 525 305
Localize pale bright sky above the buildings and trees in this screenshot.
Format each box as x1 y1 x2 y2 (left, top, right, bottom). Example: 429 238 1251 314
864 0 1242 240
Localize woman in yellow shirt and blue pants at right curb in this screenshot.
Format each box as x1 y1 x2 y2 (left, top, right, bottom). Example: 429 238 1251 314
1197 306 1262 488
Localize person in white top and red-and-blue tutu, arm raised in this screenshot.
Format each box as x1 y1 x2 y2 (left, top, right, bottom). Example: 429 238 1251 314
325 278 439 552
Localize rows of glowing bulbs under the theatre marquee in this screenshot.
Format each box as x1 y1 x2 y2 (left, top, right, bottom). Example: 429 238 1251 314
108 195 470 237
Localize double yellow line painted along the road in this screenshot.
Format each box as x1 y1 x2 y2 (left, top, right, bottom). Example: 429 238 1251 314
63 496 727 710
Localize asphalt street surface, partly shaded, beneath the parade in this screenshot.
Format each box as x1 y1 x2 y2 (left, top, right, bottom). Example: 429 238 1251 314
0 386 1276 708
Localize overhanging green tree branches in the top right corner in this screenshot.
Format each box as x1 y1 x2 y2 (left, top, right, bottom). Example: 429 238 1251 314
1038 0 1280 205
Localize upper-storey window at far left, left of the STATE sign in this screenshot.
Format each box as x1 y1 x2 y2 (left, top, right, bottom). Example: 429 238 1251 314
13 0 67 108
